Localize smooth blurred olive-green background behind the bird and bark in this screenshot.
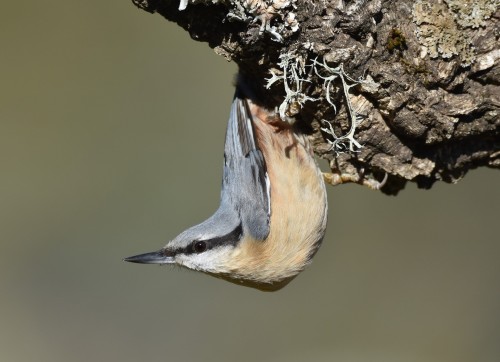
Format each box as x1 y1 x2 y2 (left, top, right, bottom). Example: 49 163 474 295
0 0 500 362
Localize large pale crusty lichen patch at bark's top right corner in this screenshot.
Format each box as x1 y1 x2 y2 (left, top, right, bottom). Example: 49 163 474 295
413 0 499 66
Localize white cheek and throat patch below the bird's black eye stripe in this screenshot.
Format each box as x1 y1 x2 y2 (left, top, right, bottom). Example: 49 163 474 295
175 246 234 273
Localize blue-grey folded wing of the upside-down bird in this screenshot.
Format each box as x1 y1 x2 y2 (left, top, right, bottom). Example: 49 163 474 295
221 96 271 240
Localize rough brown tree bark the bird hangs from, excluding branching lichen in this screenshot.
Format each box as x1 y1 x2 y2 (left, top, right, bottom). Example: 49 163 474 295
133 0 500 194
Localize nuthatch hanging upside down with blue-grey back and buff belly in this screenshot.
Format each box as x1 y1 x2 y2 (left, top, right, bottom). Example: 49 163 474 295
125 76 327 291
